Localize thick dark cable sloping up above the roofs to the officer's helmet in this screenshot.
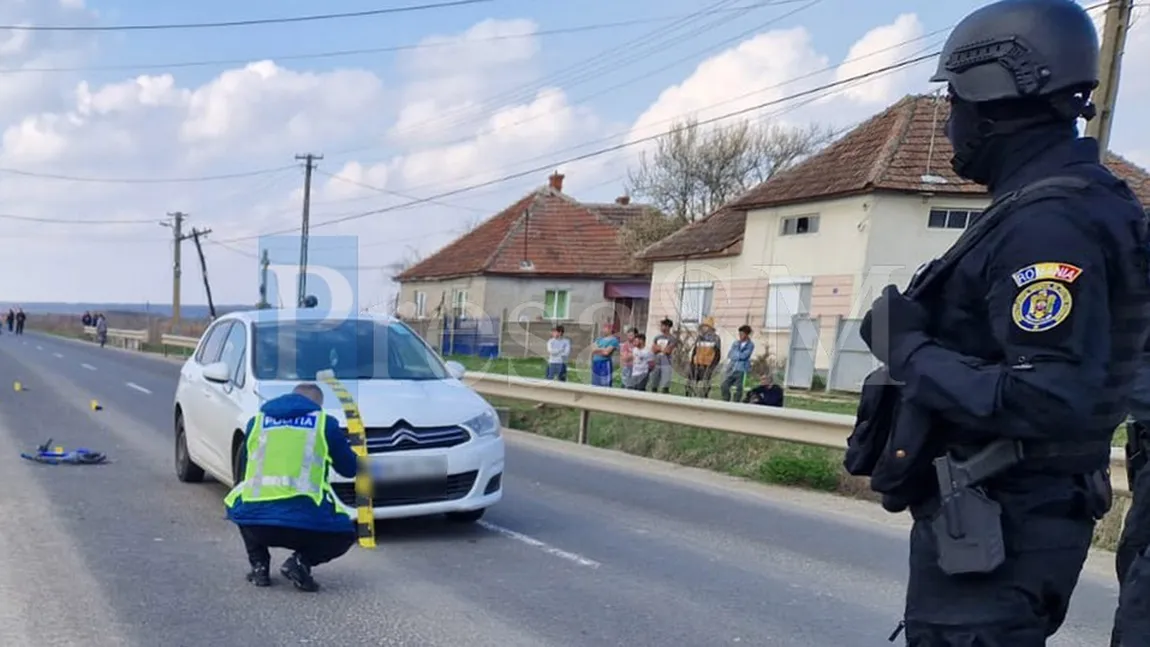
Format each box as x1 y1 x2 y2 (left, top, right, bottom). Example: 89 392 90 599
217 52 938 242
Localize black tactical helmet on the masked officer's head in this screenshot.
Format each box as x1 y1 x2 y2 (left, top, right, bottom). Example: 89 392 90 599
930 0 1098 103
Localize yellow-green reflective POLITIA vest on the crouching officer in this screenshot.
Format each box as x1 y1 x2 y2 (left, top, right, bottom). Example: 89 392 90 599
224 411 346 514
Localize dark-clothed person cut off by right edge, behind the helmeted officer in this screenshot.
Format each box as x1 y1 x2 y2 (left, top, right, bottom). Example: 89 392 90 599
1110 376 1150 647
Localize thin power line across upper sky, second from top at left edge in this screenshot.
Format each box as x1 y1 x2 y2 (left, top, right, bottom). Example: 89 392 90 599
0 0 800 75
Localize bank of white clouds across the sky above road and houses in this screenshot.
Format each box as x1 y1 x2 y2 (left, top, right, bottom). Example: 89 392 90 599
0 0 1150 302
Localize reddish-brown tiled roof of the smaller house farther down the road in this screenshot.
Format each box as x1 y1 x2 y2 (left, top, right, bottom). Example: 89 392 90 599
396 179 652 282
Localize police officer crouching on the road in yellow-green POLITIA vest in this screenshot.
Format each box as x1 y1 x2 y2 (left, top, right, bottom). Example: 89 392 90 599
224 383 370 592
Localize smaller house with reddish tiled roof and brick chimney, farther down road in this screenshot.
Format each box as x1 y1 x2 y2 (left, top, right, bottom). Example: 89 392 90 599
396 172 653 328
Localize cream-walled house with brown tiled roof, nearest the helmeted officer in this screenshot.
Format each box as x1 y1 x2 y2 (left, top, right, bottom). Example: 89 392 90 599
638 95 1150 376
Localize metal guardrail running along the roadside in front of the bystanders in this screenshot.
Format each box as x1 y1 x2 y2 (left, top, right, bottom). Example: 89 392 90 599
78 329 1129 494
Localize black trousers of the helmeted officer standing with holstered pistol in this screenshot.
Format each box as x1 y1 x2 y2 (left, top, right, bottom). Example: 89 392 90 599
904 476 1095 647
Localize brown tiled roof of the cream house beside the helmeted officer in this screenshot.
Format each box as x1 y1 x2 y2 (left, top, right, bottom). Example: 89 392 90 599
639 95 1150 261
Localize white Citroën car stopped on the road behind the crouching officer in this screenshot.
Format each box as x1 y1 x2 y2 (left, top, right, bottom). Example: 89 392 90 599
174 309 504 523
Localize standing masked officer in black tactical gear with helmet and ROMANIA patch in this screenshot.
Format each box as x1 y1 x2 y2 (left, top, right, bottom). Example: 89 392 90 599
846 0 1150 647
